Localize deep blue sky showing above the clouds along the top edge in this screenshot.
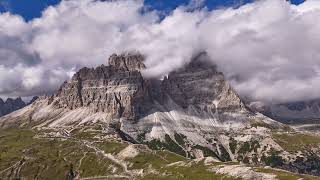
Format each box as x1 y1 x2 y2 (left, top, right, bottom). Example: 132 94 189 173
0 0 304 21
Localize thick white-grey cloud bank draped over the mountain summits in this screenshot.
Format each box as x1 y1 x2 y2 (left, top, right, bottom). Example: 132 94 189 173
0 0 320 102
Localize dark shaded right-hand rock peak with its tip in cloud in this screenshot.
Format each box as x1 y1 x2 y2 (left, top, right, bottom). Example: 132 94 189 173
162 54 243 113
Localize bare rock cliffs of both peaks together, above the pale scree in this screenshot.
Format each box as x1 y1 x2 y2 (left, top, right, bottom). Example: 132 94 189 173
49 51 243 120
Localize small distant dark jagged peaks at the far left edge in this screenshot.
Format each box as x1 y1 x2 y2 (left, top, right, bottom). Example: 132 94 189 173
0 97 26 116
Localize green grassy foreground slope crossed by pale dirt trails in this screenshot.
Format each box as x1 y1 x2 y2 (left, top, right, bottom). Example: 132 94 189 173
0 129 317 180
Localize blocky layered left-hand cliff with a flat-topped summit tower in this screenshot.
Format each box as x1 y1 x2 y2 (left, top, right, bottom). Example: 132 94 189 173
53 54 151 119
